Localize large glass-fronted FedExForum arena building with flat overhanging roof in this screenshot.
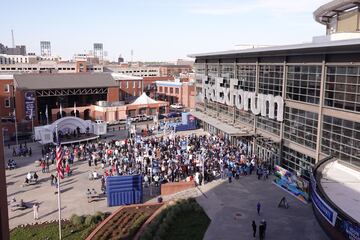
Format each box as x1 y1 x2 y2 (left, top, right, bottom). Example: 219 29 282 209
191 0 360 239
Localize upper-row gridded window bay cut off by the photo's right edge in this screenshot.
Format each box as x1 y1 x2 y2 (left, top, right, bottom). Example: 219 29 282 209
325 66 360 112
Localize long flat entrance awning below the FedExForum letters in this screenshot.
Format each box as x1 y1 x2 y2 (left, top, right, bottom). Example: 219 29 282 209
190 111 254 137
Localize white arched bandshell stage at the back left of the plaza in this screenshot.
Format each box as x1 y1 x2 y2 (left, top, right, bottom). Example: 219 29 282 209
34 117 107 144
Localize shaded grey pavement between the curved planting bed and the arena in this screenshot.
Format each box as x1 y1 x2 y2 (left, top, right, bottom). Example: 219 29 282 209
197 175 328 240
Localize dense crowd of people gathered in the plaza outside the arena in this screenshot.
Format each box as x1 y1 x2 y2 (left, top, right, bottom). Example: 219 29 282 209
36 133 271 193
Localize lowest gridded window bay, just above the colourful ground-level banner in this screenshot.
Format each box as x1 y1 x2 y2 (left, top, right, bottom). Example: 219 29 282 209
282 146 315 178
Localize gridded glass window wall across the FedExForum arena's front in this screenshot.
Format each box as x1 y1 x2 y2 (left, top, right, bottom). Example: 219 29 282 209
196 60 360 172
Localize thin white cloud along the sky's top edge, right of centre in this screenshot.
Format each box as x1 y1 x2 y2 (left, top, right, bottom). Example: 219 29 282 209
189 0 329 15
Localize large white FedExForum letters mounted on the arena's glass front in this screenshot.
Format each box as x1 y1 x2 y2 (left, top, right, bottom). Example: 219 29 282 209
201 75 284 122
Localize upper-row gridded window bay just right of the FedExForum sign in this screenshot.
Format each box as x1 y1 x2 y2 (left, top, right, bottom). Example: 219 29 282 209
286 66 321 104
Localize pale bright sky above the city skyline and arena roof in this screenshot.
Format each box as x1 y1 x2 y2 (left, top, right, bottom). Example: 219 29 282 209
0 0 329 61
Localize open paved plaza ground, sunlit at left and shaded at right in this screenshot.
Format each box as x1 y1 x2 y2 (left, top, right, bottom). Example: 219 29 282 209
5 129 328 240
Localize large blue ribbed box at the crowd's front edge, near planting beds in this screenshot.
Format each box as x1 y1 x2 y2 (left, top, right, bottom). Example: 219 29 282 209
106 175 143 207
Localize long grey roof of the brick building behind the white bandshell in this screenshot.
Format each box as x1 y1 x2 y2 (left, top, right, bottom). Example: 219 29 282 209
14 73 118 90
